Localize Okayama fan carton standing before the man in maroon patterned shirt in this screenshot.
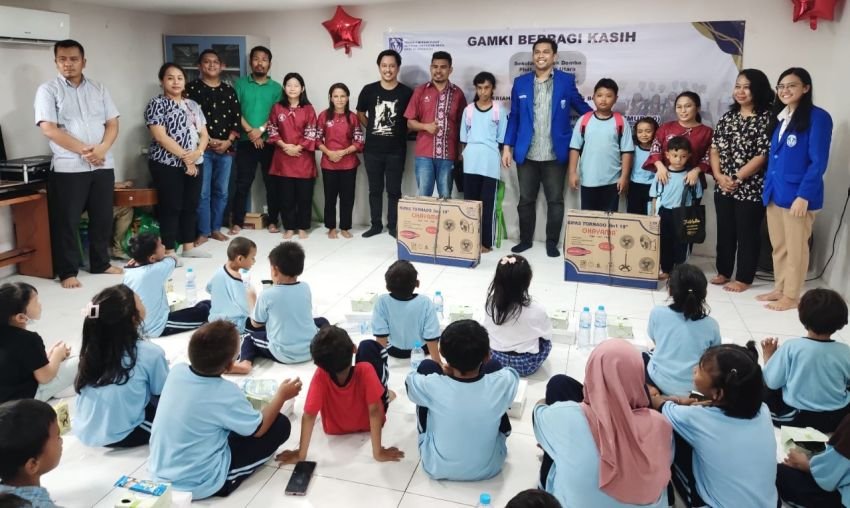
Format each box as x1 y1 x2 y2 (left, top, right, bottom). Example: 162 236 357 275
398 197 481 268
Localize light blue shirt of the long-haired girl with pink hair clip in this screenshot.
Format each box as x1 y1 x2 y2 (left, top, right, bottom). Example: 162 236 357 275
74 340 168 446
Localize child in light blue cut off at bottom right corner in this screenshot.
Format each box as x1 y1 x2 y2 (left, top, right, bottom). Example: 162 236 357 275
776 416 850 508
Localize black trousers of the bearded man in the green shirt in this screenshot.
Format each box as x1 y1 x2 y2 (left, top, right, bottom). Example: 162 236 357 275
232 141 280 226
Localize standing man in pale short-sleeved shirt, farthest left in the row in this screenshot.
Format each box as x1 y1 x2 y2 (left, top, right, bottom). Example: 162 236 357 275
34 39 122 288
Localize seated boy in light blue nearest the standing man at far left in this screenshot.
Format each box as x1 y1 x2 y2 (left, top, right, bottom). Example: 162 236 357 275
124 233 210 338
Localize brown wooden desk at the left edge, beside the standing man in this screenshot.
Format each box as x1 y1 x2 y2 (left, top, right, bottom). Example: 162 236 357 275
0 181 53 279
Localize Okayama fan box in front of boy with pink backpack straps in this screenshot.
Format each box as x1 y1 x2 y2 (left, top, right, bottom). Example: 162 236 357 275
564 210 661 289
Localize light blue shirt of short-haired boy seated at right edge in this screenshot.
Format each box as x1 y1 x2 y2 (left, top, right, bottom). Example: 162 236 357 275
764 338 850 411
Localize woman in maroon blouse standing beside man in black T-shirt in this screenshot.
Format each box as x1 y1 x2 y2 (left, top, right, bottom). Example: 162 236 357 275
318 83 363 238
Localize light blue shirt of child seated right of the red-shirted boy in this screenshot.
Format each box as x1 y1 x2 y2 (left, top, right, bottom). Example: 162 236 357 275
406 367 519 481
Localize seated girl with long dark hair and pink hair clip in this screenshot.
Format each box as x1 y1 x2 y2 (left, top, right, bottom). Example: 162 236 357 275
73 284 168 448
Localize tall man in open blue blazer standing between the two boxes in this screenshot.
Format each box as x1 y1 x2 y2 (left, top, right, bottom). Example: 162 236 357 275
502 38 591 257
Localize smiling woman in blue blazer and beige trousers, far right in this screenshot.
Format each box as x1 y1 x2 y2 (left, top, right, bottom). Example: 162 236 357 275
756 67 832 310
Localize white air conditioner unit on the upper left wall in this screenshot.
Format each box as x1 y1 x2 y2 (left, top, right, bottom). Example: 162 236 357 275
0 6 71 44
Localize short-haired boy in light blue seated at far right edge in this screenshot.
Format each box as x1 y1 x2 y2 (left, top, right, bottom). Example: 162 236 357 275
761 288 850 433
